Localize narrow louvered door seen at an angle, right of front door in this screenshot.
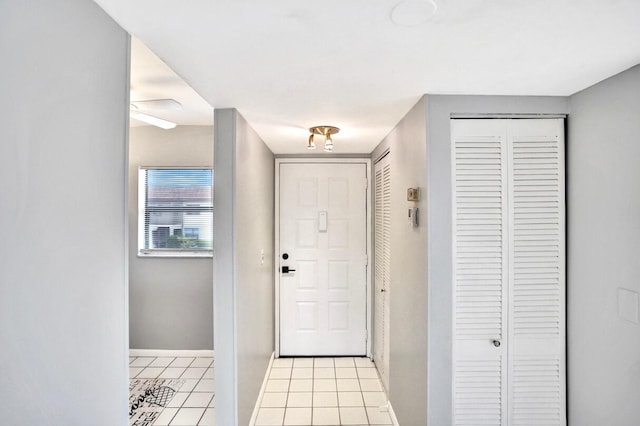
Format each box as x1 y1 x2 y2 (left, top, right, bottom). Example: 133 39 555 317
373 153 391 391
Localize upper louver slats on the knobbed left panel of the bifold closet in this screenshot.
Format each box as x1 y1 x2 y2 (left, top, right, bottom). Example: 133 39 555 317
455 137 503 340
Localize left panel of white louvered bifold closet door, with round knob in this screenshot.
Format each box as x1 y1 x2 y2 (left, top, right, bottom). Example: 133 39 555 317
451 120 508 426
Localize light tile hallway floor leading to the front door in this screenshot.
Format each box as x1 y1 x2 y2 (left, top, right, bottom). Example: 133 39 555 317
255 358 392 426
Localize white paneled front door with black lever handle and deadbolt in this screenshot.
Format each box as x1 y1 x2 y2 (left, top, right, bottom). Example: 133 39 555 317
278 162 367 356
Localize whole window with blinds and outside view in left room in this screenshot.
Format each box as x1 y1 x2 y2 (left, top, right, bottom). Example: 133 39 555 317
138 167 213 257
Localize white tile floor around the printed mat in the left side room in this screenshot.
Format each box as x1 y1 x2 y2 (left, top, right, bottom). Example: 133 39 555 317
129 357 215 426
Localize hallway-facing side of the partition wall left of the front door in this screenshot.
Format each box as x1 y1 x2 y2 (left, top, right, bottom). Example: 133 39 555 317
235 113 275 425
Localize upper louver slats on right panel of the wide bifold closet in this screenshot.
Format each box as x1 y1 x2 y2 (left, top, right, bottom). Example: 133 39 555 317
512 136 564 337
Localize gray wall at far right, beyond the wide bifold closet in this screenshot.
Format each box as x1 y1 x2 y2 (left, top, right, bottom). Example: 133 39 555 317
567 66 640 426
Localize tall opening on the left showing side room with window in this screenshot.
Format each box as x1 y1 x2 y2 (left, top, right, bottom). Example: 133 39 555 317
128 38 215 425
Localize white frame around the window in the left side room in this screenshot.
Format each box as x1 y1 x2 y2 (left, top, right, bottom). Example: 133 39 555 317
136 166 213 258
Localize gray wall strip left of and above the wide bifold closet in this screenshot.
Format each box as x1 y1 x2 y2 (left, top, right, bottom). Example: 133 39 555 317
426 95 568 425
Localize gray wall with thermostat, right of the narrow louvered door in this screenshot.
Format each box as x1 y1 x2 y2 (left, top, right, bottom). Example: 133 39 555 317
372 97 428 425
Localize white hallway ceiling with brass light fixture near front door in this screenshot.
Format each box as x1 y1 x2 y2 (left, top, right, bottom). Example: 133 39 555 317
95 0 640 153
